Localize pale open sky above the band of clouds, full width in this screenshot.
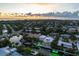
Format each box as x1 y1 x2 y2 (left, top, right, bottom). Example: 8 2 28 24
0 3 79 14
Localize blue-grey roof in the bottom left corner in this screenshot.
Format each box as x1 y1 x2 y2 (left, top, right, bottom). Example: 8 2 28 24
0 47 21 56
